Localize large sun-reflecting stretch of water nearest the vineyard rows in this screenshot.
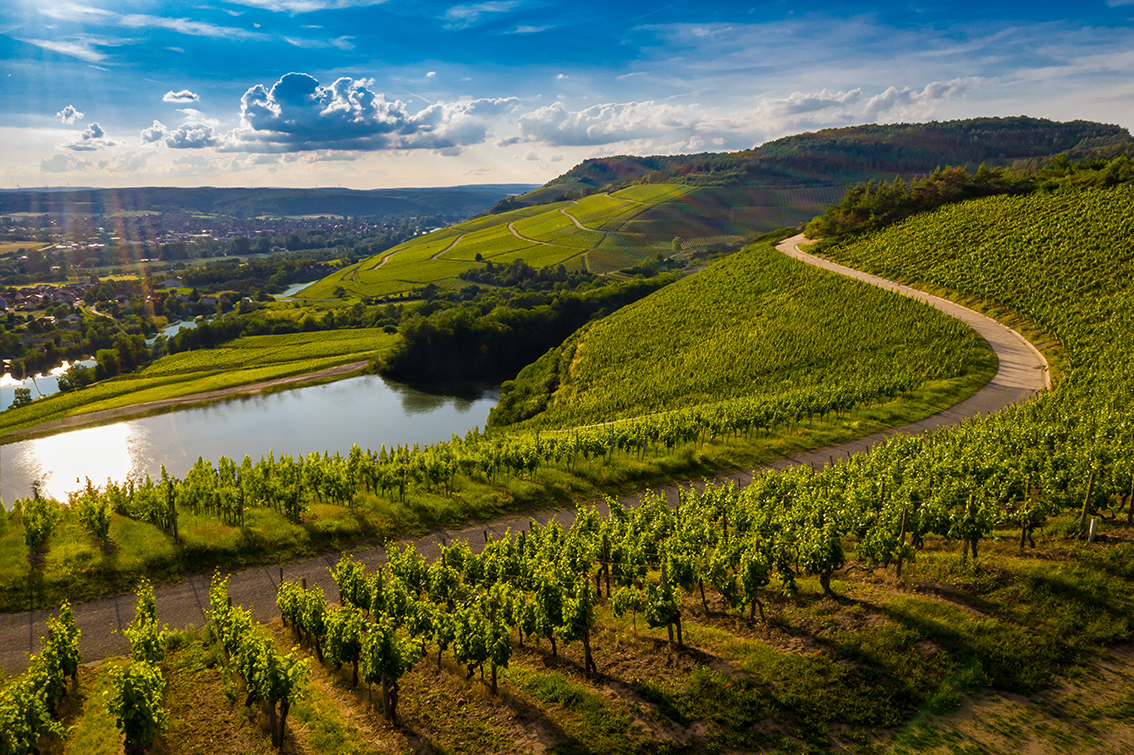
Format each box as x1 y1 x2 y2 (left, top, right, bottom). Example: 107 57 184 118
0 375 500 506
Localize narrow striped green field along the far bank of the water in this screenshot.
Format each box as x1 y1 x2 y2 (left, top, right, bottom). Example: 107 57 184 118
0 329 397 434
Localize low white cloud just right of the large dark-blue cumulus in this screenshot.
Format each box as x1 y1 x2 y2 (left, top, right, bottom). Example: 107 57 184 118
519 100 694 146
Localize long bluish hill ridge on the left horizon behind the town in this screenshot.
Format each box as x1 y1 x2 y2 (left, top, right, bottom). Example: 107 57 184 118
0 184 533 220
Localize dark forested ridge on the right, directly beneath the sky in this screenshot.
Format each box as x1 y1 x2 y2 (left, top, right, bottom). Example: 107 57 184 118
493 117 1134 211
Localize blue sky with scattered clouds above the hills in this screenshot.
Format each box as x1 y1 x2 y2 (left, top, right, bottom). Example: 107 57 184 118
0 0 1134 189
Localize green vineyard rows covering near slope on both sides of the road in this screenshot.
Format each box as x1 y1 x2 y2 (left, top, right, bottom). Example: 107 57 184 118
0 179 1134 755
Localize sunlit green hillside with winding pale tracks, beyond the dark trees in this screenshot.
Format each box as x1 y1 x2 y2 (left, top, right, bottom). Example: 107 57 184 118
302 184 830 299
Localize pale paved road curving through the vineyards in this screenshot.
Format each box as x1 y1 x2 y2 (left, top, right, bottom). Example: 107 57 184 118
0 236 1050 673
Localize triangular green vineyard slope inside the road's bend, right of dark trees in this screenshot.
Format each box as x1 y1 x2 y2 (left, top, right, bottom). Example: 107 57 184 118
490 244 985 427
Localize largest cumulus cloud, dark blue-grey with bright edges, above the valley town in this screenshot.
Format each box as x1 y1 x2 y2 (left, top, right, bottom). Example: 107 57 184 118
221 73 519 154
